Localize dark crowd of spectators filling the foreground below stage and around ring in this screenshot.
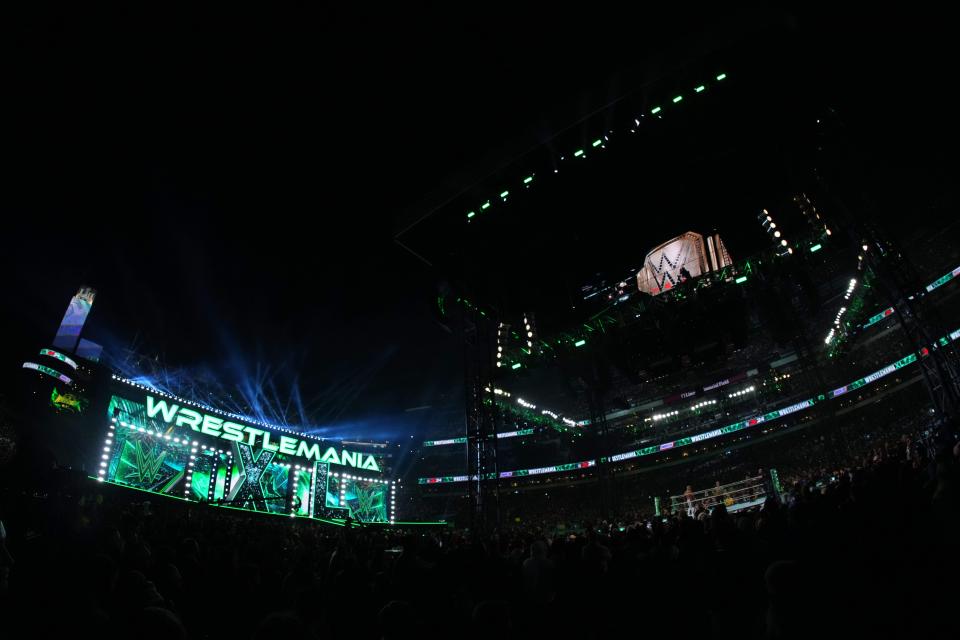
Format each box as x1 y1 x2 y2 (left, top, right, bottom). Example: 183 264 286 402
0 388 960 640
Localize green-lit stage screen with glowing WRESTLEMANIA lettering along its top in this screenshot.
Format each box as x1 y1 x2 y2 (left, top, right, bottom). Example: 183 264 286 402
98 393 392 522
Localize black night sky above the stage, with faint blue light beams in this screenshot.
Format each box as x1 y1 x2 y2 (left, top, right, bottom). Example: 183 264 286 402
7 3 955 435
